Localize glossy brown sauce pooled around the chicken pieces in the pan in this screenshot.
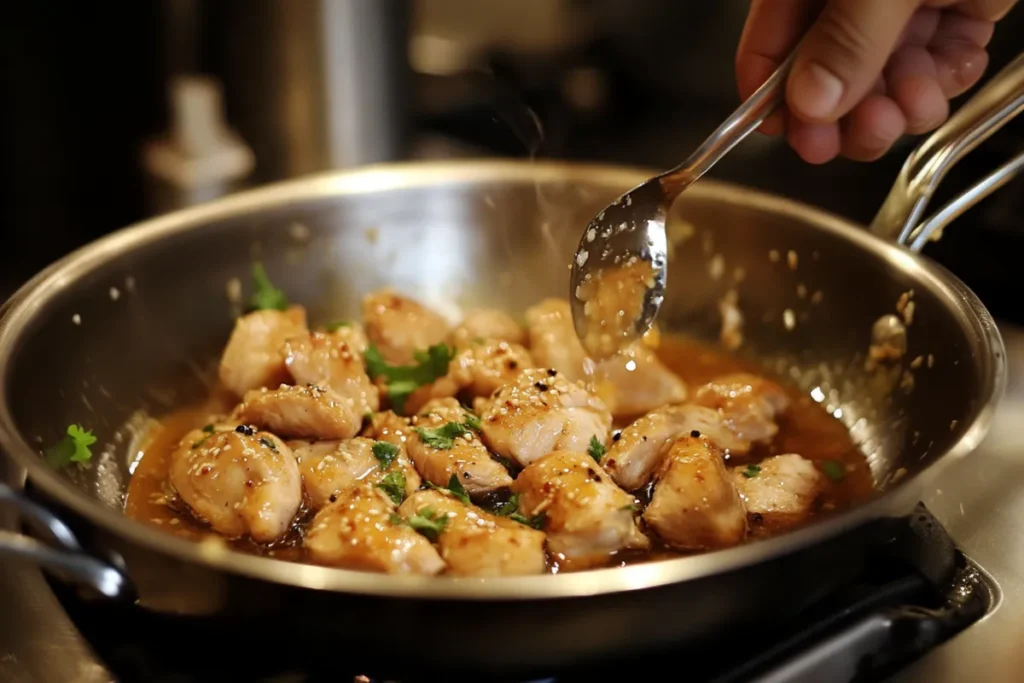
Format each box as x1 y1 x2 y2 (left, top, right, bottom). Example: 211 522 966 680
125 335 874 564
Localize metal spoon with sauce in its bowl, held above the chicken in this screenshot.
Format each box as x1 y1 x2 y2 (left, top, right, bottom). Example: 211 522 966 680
569 50 797 360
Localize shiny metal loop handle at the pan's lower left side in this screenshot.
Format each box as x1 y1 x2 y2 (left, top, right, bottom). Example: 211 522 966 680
0 483 134 600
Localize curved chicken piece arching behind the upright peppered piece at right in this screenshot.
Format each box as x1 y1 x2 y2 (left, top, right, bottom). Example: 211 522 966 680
603 404 751 490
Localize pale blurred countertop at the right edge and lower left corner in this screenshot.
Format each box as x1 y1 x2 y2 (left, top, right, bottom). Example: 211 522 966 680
6 324 1024 683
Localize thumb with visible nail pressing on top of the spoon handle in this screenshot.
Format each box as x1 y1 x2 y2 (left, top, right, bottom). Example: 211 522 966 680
785 0 921 123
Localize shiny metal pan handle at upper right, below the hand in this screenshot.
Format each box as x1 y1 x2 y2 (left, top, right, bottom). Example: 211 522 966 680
871 53 1024 251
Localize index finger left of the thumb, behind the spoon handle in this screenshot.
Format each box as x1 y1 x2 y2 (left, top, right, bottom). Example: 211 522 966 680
736 0 821 135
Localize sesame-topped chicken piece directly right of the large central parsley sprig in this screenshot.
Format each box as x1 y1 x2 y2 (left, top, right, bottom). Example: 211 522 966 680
406 340 534 413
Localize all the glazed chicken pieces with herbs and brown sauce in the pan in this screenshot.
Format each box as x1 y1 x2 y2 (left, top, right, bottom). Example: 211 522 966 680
121 280 870 578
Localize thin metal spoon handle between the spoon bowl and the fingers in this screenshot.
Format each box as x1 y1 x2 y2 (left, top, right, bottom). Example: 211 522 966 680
659 49 797 194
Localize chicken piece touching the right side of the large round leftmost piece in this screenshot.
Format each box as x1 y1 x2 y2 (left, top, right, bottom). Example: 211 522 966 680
288 436 421 510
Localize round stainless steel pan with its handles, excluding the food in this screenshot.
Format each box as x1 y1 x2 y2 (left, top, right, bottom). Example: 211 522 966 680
0 53 1024 675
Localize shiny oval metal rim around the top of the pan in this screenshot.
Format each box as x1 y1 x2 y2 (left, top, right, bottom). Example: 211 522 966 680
0 159 1007 601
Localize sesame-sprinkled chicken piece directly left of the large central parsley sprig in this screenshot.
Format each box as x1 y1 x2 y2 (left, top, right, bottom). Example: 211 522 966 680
285 331 380 416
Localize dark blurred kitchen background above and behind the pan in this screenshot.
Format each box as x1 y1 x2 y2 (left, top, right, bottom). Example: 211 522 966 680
0 0 1024 319
